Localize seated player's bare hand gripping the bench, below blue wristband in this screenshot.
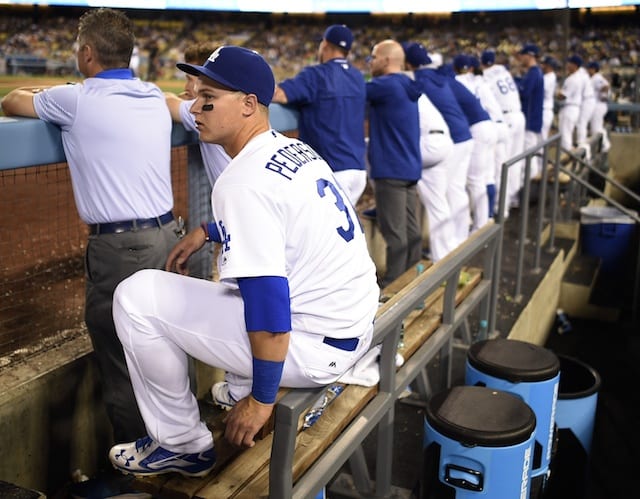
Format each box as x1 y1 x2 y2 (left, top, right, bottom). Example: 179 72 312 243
223 395 273 447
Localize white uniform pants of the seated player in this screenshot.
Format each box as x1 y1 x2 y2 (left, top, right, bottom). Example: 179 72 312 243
114 270 373 453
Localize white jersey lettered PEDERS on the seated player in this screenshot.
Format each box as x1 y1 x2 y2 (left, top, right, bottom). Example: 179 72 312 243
211 130 379 338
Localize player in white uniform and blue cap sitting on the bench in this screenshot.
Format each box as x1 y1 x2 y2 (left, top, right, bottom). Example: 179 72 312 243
109 46 380 476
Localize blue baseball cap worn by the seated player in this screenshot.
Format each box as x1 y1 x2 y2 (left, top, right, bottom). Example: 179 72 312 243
176 45 276 106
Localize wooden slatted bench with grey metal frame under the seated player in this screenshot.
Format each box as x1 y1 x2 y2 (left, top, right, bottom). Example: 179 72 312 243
130 224 501 499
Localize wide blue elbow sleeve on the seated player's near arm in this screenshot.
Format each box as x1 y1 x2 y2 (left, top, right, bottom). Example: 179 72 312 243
238 276 291 333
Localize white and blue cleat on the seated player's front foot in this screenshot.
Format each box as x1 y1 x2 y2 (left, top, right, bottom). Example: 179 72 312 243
109 436 216 477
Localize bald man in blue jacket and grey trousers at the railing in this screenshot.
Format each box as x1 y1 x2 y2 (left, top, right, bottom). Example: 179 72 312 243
367 40 422 287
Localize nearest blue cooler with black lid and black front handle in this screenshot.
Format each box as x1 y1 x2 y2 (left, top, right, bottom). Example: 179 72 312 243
419 386 536 499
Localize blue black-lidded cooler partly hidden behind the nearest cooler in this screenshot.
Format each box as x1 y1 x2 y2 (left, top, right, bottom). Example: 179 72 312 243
465 338 560 499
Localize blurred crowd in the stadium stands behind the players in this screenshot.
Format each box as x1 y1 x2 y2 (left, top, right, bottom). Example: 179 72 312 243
0 9 640 101
